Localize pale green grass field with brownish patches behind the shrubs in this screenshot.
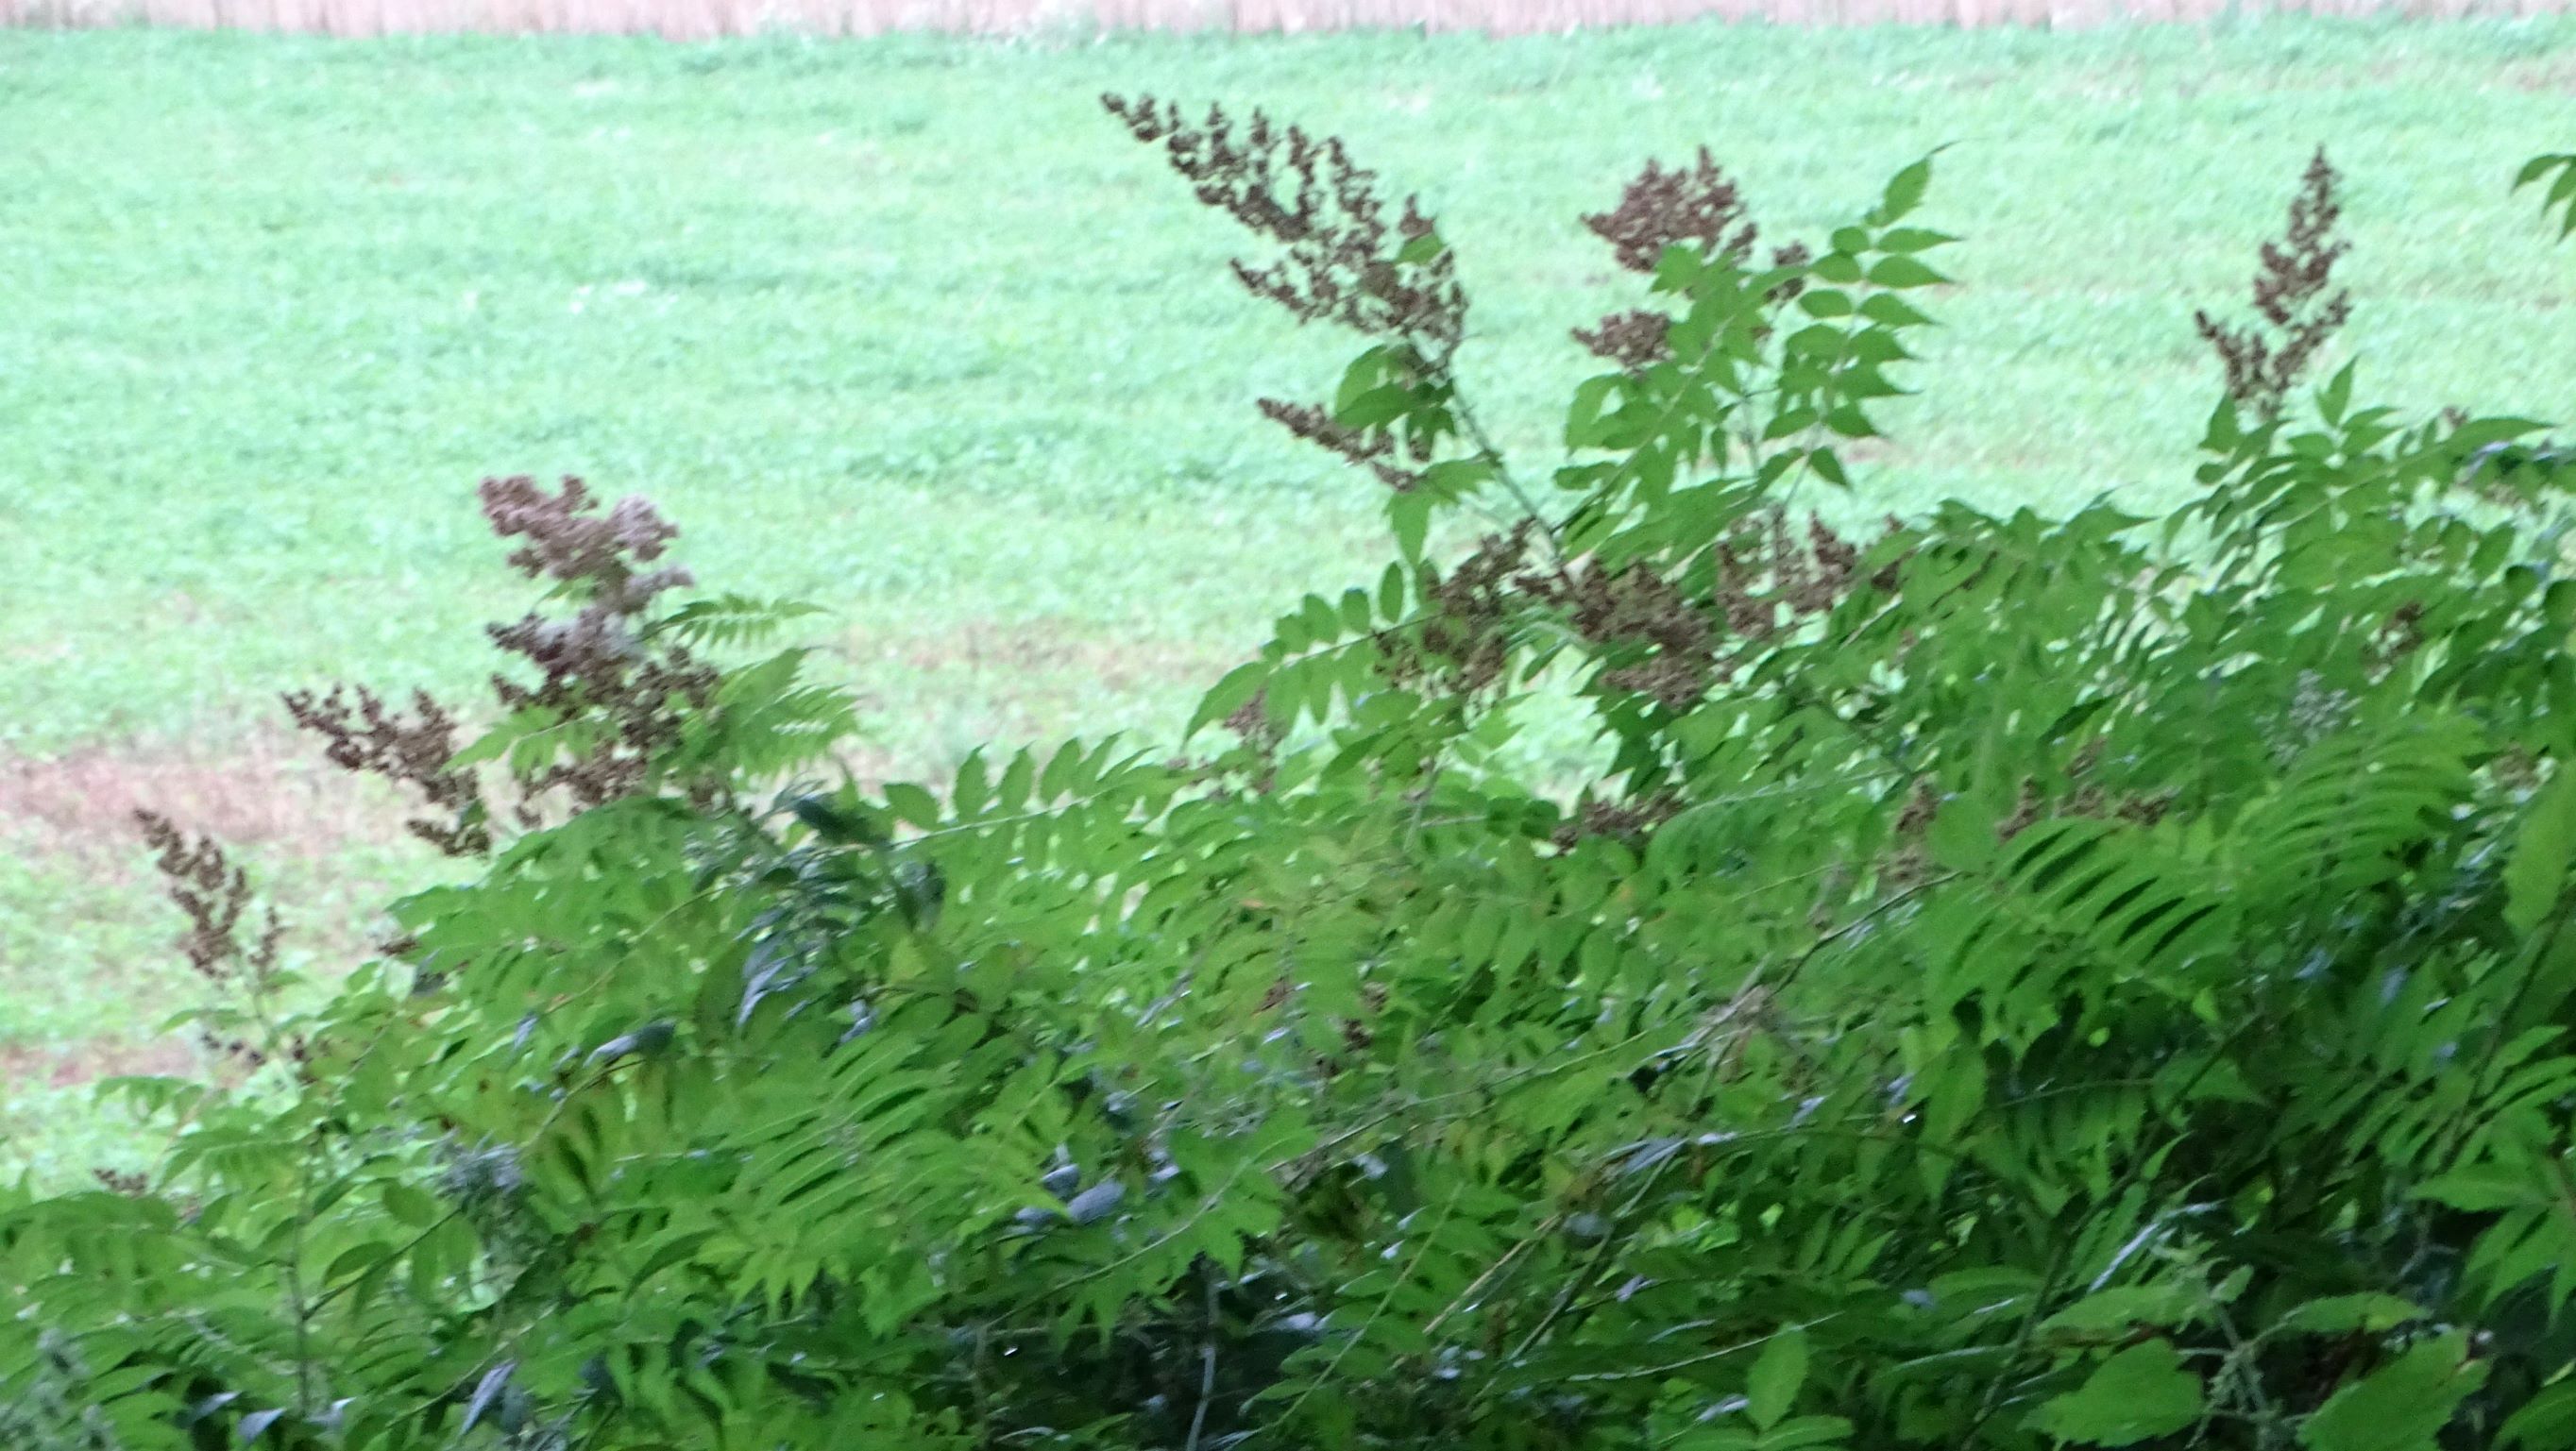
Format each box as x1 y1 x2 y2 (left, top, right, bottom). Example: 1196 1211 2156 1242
0 21 2576 1178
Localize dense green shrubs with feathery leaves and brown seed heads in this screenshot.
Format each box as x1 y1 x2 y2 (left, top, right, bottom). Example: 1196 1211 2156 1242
15 91 2576 1451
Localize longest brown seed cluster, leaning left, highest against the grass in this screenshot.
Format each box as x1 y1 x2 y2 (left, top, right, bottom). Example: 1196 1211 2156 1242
1100 95 1466 353
